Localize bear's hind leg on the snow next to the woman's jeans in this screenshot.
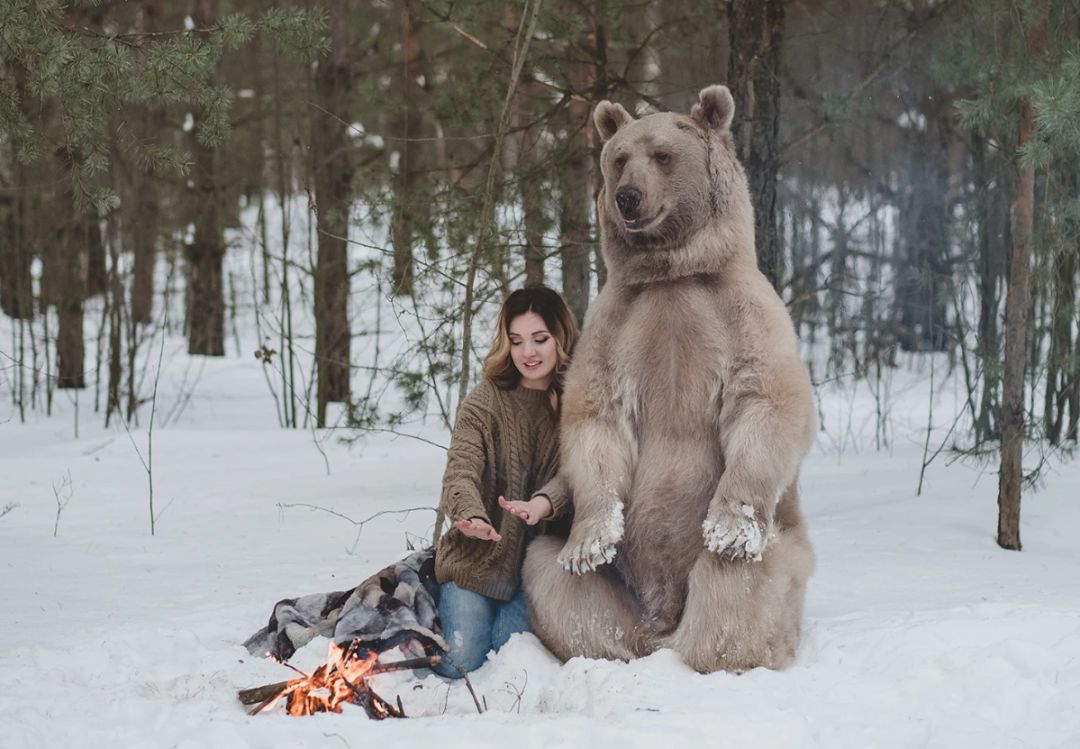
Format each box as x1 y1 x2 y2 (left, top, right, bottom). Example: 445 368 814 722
522 536 645 661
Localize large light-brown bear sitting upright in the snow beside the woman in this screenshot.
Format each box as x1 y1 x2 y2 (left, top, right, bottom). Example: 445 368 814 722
523 85 814 672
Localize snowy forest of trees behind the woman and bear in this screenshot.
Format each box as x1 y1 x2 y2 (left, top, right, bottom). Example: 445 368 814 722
0 0 1080 548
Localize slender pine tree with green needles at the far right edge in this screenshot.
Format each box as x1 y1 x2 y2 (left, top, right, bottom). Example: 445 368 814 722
958 0 1080 550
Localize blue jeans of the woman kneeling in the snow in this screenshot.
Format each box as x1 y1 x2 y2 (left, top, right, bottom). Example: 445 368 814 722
432 583 532 679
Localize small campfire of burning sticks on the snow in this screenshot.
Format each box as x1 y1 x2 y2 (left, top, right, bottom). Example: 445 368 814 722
239 640 441 720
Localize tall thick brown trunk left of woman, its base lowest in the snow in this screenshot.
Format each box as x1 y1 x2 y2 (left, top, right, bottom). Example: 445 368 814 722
311 0 352 426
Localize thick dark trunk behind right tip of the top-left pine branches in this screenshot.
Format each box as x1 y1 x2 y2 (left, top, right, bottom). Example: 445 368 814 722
187 0 225 356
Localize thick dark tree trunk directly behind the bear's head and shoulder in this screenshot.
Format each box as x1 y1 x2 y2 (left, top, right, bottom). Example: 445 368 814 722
727 0 785 289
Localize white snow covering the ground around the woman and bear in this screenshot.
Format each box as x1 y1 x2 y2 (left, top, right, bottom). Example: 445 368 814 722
0 256 1080 749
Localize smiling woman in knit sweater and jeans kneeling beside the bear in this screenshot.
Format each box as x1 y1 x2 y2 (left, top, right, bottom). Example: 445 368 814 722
435 286 577 679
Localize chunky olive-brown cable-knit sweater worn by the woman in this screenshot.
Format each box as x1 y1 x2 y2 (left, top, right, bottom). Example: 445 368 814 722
435 378 569 600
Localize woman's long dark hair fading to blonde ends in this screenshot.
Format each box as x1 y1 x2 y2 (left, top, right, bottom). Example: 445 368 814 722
484 286 578 407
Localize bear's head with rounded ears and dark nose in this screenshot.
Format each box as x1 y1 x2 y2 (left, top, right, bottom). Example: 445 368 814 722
593 85 754 275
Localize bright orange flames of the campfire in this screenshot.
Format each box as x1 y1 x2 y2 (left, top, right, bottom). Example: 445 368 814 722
258 642 389 718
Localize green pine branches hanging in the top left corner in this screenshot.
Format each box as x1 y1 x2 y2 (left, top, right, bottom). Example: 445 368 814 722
0 0 253 210
